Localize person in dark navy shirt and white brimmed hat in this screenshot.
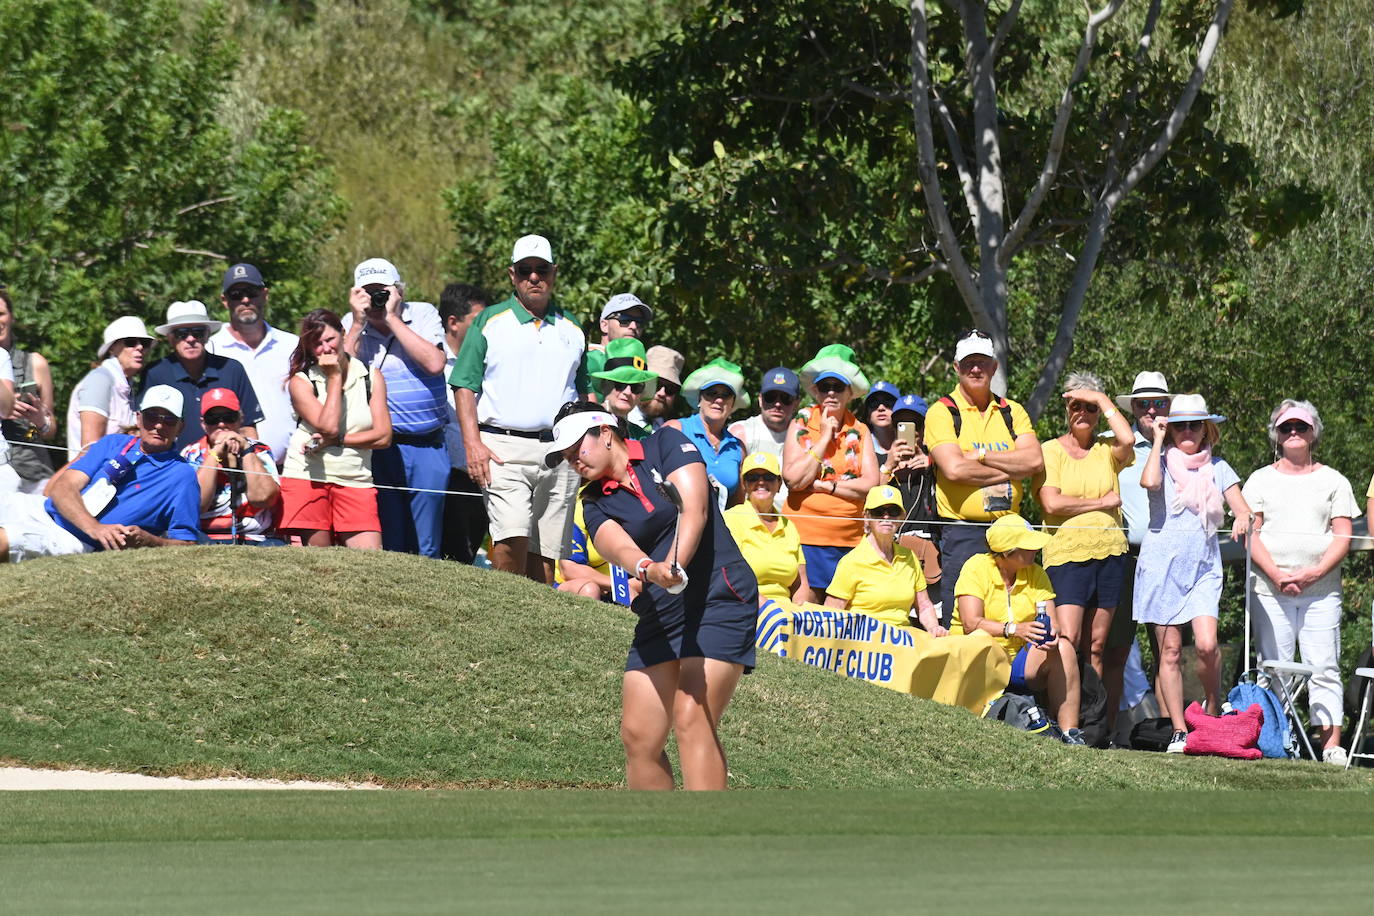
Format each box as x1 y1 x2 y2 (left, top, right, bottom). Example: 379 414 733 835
142 299 262 450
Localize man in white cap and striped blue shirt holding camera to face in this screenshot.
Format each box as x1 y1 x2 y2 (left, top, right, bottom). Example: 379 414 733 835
344 258 449 558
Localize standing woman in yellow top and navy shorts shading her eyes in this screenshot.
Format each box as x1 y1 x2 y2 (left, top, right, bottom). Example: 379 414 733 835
1036 372 1135 677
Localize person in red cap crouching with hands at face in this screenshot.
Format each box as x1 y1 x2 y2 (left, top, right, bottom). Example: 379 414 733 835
181 387 283 547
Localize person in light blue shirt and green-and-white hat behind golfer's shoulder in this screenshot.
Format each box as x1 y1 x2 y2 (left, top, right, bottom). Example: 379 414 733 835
665 357 749 511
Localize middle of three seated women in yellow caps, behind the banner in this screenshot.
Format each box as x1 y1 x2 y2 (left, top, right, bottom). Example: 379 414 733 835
826 486 948 636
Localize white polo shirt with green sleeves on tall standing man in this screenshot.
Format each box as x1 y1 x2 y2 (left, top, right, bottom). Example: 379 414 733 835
448 297 587 433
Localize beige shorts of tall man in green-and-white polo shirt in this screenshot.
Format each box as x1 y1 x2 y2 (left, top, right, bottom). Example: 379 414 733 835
481 433 581 560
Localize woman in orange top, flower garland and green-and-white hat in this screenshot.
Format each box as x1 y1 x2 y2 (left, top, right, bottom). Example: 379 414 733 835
782 343 878 597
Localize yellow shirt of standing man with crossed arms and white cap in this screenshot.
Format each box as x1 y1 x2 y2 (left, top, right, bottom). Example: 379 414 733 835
926 387 1035 522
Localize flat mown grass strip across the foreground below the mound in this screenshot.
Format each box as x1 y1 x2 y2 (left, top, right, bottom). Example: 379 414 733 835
0 791 1374 913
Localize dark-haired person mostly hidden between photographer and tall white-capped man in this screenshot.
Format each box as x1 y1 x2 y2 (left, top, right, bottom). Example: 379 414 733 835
438 283 492 563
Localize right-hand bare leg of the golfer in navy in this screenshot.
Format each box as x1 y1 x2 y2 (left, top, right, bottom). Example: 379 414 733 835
673 658 745 790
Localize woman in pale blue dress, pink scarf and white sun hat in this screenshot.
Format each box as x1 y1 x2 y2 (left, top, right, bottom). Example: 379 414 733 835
1135 394 1250 754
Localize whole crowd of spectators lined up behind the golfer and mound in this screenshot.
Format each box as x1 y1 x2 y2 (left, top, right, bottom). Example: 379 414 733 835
0 235 1374 766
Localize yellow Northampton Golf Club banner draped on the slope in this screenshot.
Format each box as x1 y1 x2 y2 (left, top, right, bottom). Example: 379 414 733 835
757 600 1011 715
